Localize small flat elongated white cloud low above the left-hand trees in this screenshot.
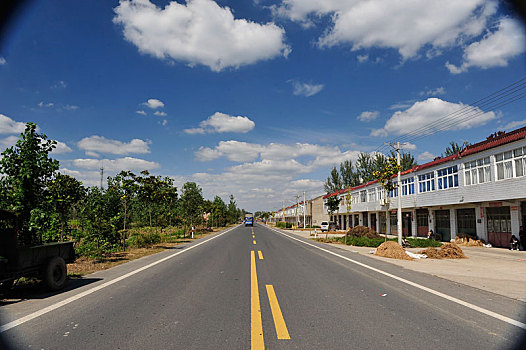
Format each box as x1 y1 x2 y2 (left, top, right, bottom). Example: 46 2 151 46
77 135 150 156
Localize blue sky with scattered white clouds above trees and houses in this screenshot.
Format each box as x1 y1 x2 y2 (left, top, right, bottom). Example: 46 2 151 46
0 0 526 210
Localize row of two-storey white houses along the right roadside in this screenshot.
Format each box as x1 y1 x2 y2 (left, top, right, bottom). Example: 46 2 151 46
273 127 526 247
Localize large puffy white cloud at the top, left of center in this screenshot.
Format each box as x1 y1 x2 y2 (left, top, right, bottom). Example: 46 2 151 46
113 0 290 72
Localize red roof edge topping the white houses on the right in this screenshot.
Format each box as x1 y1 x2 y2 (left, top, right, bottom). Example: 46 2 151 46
323 126 526 199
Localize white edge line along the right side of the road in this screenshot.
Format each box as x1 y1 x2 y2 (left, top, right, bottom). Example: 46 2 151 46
268 227 526 329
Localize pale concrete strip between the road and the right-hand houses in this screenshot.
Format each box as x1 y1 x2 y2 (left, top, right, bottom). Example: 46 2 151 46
285 230 526 302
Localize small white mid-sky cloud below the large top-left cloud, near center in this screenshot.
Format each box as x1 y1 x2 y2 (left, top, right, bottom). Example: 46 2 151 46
184 112 256 134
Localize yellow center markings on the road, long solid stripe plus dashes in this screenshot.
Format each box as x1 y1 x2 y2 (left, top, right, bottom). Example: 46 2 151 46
250 249 290 350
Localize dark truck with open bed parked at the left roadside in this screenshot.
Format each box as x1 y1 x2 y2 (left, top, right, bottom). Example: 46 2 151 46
0 210 75 291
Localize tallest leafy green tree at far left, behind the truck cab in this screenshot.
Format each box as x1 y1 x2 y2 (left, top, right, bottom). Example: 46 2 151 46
0 123 59 245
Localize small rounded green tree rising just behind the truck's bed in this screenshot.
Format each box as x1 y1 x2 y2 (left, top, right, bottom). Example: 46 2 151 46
47 173 86 242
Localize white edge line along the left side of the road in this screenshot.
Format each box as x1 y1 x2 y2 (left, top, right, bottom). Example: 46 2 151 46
0 226 238 333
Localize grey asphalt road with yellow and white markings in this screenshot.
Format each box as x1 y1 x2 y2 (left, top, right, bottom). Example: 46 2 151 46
0 225 526 350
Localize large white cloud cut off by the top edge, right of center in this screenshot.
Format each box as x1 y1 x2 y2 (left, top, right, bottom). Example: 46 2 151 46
274 0 497 59
